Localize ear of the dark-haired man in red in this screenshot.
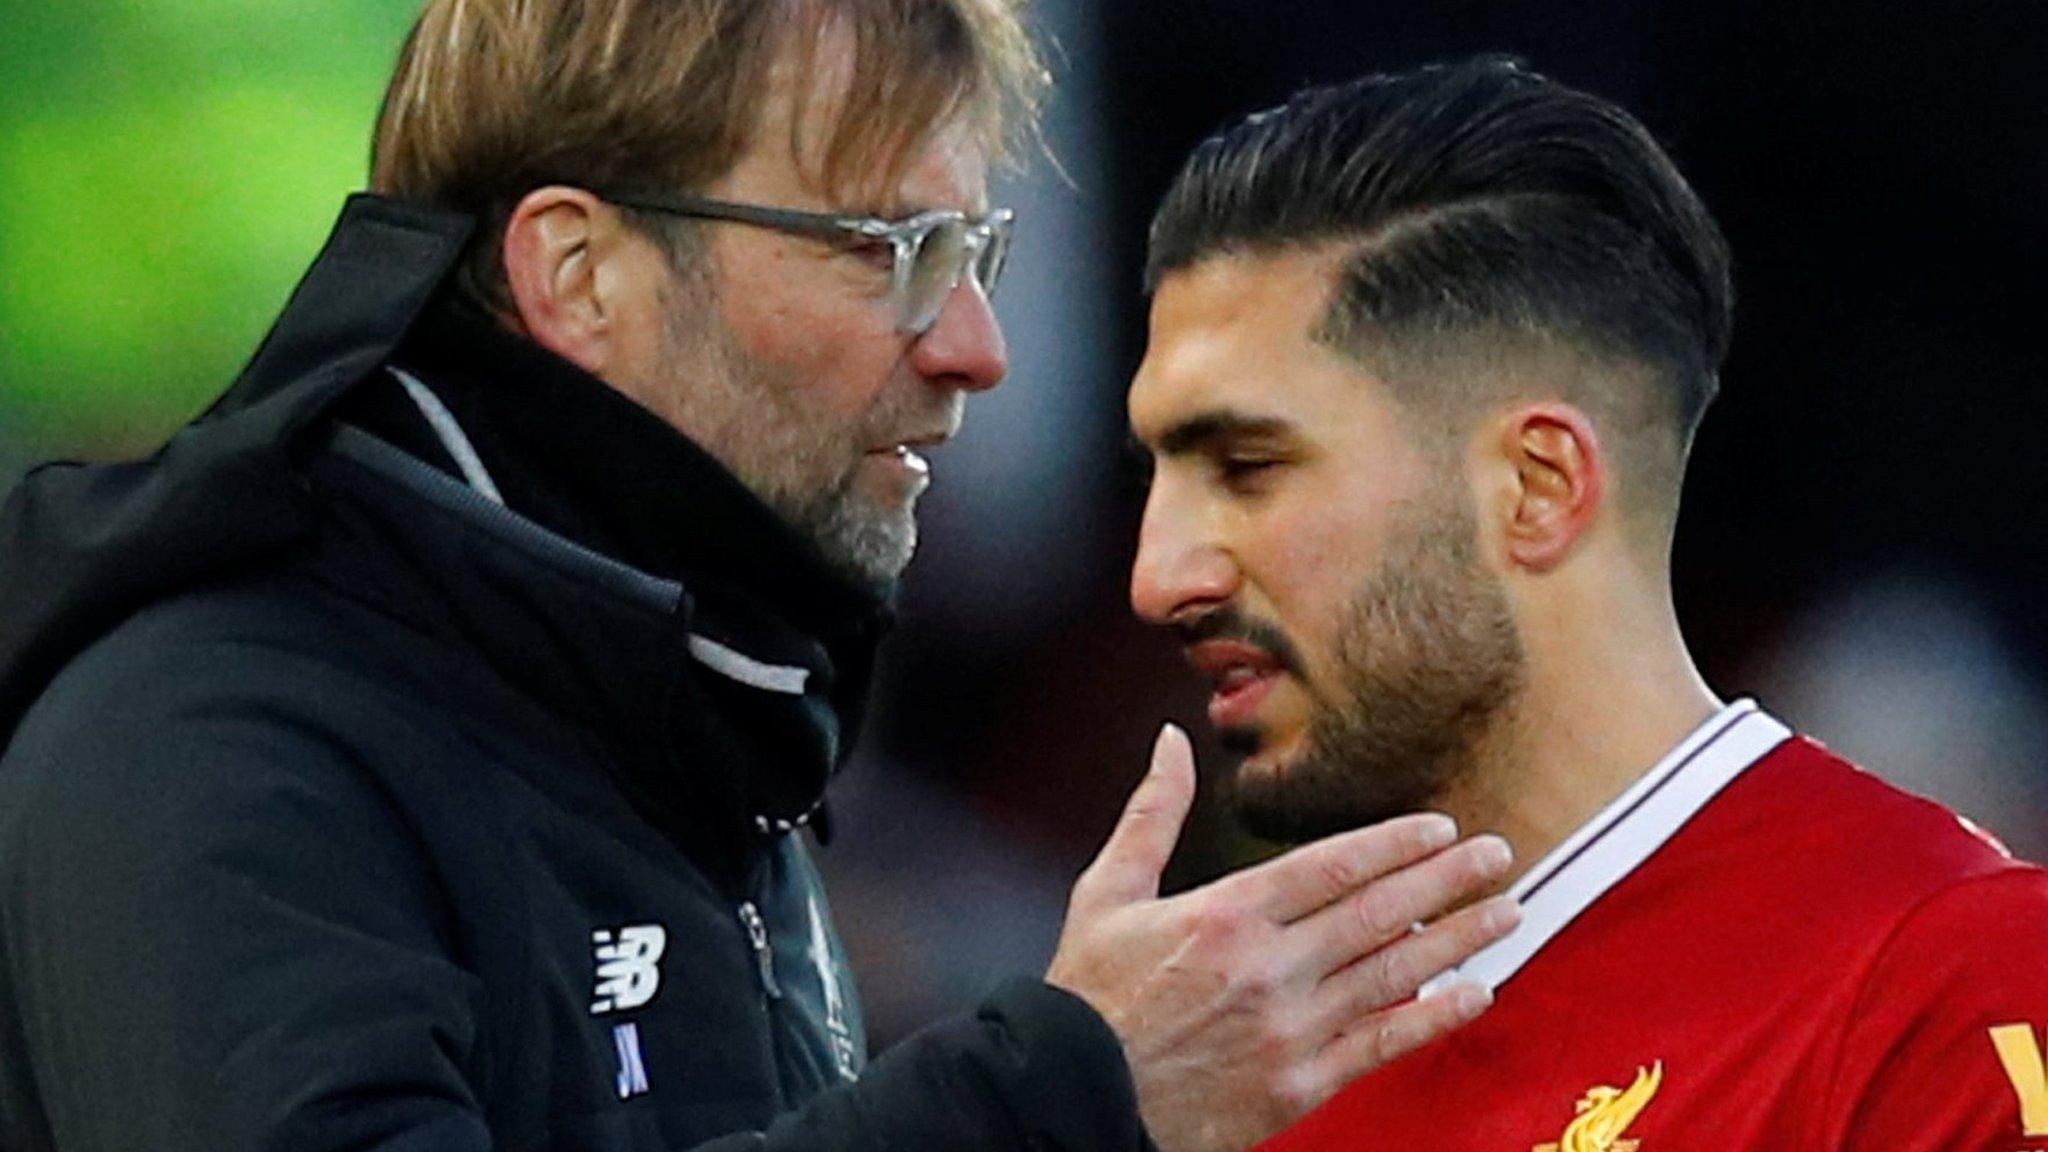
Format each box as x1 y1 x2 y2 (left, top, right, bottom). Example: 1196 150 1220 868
1499 402 1610 572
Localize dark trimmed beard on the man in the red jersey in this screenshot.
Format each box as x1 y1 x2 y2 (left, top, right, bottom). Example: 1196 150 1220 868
1225 478 1524 842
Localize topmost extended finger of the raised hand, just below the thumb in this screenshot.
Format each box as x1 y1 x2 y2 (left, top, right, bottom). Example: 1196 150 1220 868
1217 812 1458 929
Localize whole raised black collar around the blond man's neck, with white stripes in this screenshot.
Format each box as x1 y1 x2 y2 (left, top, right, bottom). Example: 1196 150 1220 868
323 233 891 848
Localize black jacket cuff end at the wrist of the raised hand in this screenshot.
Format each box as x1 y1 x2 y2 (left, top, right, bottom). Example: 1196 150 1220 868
696 980 1151 1152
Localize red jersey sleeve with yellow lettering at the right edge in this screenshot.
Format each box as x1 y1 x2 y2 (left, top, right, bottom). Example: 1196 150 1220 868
1825 867 2048 1152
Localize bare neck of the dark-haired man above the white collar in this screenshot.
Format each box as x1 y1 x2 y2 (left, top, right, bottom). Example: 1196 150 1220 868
1440 573 1720 888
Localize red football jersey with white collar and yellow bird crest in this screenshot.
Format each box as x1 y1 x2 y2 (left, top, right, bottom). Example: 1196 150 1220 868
1266 701 2048 1152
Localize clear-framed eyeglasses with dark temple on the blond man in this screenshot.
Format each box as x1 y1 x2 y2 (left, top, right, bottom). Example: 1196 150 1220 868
598 193 1016 336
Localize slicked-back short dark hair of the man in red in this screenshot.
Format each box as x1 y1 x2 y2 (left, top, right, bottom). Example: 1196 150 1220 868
1145 57 1735 528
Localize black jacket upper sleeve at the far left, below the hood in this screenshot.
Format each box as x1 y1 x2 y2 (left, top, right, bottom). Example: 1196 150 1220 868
0 666 489 1152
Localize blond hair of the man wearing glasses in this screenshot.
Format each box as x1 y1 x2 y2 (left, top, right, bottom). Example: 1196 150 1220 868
371 0 1047 303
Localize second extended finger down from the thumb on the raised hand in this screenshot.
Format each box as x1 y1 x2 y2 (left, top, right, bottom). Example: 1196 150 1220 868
1290 836 1513 980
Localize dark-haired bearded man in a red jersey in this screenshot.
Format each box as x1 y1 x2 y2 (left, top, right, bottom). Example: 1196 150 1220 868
1130 61 2048 1152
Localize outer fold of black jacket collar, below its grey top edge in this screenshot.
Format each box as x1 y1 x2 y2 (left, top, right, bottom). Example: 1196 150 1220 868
309 416 881 853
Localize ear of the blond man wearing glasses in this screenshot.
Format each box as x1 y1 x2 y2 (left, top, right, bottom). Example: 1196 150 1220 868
504 184 621 375
